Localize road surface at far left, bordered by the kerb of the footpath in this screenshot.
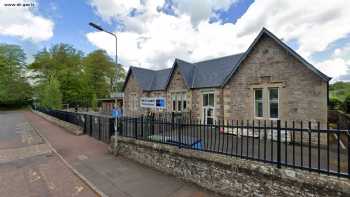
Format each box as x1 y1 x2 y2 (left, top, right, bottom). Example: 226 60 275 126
0 111 97 197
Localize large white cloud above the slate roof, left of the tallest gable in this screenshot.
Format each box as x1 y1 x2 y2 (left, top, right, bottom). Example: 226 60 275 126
87 0 246 68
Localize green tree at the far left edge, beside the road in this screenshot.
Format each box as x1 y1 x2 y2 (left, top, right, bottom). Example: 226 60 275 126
0 44 32 107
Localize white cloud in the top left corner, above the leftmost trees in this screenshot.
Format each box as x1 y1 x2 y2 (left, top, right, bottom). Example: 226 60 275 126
0 0 54 42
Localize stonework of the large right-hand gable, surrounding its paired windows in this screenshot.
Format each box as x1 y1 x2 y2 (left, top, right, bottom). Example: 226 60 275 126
223 36 327 126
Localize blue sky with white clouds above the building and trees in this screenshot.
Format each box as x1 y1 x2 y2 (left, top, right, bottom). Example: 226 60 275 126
0 0 350 82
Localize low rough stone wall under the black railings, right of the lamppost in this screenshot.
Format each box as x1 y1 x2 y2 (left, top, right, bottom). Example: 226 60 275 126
110 136 350 196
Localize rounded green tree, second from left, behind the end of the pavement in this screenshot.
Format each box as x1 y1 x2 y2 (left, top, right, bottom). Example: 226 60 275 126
29 44 88 105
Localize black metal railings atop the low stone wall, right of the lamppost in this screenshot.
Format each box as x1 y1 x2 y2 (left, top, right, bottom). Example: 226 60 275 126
117 116 350 177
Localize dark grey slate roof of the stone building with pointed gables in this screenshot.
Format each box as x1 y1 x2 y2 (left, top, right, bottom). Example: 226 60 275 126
123 28 331 91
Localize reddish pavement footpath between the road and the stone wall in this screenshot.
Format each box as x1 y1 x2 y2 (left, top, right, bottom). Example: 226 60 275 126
23 111 219 197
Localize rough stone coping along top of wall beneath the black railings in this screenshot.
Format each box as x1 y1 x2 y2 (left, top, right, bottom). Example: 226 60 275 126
116 136 350 195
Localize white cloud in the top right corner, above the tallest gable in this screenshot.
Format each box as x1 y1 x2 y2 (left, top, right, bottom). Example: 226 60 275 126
236 0 350 57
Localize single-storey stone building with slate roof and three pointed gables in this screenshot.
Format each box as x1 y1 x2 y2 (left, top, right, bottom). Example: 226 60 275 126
123 28 330 125
